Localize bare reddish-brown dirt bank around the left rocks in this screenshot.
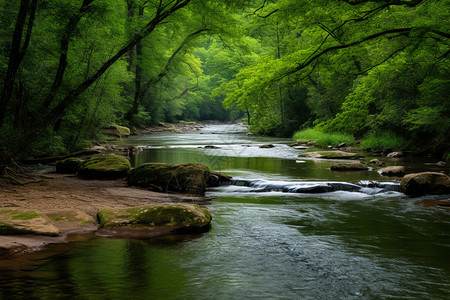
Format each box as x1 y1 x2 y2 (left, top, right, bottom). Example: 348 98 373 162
0 174 207 254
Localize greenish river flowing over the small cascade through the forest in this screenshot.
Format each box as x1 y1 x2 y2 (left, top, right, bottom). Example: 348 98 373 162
0 125 450 299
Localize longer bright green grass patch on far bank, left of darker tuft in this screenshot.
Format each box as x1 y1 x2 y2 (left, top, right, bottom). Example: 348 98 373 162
292 128 354 147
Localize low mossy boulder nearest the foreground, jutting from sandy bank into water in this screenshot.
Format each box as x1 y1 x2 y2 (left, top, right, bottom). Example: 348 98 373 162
97 203 211 237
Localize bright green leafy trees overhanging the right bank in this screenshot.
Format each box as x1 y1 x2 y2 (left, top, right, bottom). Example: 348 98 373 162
216 0 450 150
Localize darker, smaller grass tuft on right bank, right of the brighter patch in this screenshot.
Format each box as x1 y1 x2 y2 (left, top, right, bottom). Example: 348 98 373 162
360 131 407 150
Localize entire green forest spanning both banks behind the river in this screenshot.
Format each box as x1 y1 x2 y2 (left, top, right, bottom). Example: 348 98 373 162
0 0 450 161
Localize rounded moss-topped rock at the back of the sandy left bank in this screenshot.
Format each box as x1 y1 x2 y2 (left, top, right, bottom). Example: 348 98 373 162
78 154 131 179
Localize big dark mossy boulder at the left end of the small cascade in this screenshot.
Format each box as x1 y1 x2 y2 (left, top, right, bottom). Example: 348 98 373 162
127 163 211 195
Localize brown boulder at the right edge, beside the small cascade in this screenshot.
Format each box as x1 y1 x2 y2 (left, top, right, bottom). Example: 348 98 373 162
400 172 450 196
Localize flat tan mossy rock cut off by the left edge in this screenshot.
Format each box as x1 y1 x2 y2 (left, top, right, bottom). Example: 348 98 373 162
0 209 59 236
